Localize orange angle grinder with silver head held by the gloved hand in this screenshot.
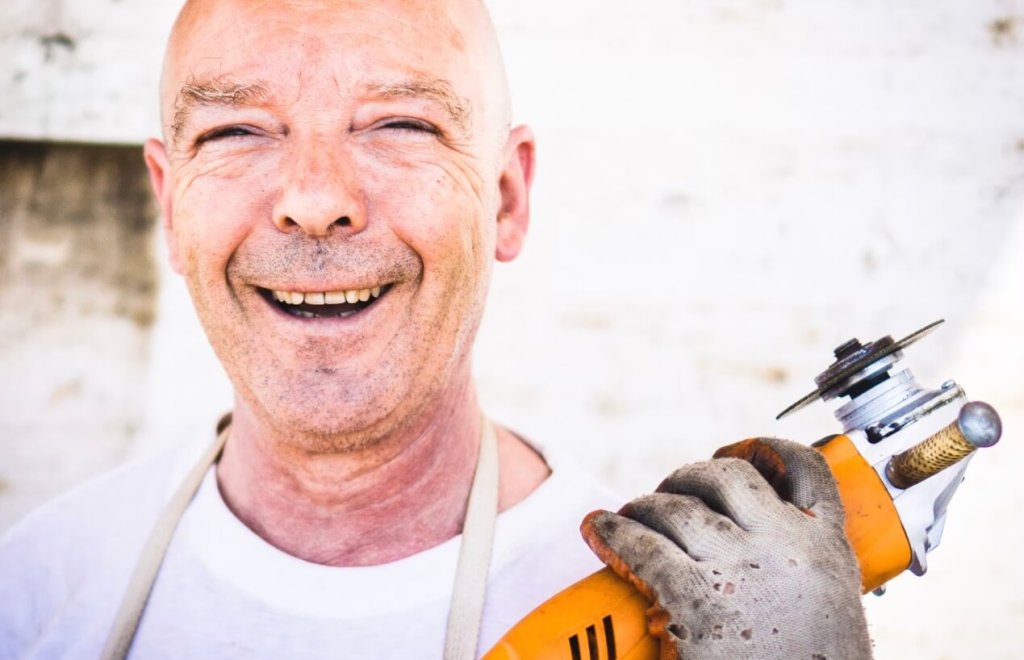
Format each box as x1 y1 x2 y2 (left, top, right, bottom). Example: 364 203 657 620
483 321 1001 660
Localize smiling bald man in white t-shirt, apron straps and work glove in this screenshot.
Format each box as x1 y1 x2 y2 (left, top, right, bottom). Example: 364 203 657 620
0 0 867 658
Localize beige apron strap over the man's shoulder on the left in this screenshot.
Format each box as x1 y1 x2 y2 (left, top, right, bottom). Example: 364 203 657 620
100 425 230 660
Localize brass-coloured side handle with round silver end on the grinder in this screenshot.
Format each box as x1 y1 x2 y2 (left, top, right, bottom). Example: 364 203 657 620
886 401 1002 489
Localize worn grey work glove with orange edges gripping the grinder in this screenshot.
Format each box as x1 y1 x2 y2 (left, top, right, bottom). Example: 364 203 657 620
582 438 871 660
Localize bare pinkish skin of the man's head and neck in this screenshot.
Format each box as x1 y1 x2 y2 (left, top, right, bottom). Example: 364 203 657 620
145 0 548 565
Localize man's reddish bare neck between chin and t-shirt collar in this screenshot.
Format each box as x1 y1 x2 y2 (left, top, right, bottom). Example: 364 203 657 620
217 379 548 566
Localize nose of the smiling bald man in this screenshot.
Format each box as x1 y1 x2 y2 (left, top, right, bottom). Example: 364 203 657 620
273 140 367 236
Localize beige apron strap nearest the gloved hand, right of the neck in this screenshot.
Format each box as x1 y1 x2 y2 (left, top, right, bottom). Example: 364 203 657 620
444 416 498 660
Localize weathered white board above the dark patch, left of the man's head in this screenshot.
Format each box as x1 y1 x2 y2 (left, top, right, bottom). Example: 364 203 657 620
0 0 174 143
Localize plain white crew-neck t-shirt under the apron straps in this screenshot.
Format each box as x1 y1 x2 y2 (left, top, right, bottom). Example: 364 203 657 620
0 435 621 660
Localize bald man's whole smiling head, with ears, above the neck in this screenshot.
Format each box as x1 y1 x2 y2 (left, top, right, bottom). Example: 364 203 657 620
145 0 532 448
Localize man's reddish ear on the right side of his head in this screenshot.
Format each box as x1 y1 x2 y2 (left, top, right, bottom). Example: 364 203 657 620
495 126 535 261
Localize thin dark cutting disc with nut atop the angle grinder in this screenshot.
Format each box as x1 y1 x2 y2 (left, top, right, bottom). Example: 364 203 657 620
775 319 944 420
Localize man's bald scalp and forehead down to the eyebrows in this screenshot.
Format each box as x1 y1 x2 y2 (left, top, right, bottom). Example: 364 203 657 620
161 0 511 149
